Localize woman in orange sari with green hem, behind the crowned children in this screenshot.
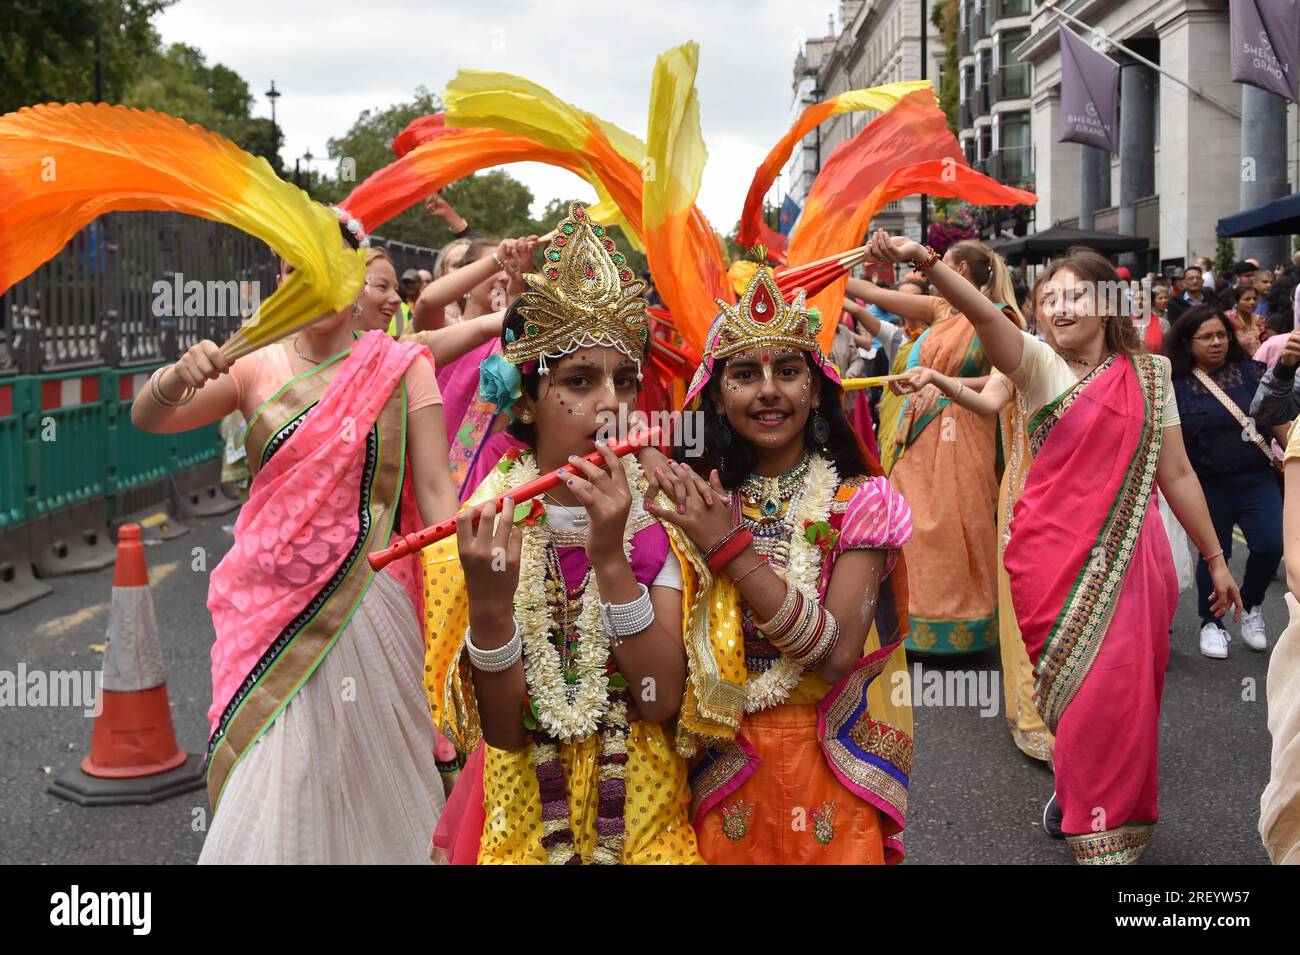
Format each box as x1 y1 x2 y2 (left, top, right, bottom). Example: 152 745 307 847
852 240 1023 654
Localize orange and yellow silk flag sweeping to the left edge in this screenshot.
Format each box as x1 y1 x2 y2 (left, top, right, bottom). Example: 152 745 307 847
0 103 365 357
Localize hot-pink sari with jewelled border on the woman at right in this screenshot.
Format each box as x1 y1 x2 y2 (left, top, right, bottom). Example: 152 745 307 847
1005 355 1178 864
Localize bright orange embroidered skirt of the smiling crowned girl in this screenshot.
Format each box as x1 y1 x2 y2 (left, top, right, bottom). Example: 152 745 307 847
696 703 884 865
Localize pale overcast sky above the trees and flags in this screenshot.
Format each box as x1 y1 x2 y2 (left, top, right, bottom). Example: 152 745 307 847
156 0 839 231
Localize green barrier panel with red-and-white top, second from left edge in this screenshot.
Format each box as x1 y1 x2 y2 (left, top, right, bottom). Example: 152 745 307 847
21 368 109 517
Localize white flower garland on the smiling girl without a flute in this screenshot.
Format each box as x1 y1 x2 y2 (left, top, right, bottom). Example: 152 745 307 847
745 455 840 713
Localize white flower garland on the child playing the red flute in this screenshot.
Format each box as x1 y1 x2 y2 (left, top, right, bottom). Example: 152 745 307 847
504 455 641 742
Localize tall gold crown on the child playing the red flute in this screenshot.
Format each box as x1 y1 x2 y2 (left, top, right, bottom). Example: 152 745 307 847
506 203 650 374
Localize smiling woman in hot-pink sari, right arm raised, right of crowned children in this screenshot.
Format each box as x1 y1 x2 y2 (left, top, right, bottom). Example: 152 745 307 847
870 231 1242 864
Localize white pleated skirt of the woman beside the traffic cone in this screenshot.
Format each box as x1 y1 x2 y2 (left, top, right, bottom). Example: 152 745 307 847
199 573 446 865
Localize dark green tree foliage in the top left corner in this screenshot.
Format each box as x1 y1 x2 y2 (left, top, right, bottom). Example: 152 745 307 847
0 0 174 113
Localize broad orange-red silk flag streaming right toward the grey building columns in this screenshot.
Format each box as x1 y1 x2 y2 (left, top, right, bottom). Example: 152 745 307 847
789 90 1037 350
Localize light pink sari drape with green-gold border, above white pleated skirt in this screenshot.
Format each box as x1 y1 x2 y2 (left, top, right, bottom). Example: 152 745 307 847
208 331 433 809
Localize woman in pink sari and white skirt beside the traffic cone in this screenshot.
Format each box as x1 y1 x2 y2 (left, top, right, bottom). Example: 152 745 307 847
131 242 456 863
